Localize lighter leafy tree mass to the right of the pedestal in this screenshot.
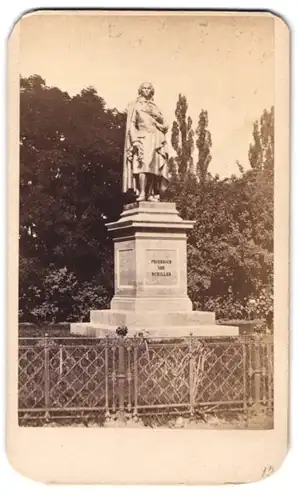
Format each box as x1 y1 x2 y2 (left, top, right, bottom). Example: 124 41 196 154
184 109 274 324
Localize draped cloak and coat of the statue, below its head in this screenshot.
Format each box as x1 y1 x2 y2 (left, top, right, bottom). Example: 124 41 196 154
123 97 168 192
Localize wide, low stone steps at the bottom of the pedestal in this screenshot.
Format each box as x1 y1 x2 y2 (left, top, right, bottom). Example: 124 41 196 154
71 309 239 337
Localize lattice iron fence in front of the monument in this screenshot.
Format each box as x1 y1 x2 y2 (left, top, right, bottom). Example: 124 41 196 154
19 335 273 424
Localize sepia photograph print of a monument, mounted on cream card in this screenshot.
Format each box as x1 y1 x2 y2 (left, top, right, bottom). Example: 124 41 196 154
17 11 280 434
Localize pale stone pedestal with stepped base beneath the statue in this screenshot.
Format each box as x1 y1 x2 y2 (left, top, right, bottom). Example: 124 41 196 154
71 202 238 337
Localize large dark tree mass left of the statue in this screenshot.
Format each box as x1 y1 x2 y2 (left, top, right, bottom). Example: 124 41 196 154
20 75 125 322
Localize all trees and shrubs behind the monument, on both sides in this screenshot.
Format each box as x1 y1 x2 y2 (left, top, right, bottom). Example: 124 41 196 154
19 75 274 324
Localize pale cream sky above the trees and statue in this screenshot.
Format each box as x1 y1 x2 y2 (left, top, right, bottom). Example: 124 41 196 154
20 11 274 177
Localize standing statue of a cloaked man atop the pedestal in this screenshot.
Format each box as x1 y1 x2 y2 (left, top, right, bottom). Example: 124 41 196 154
123 82 168 201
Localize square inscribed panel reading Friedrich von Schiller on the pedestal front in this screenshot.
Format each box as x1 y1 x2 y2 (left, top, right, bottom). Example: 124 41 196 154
145 249 178 286
